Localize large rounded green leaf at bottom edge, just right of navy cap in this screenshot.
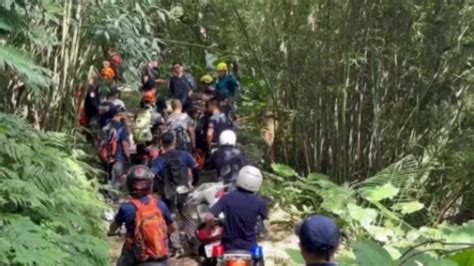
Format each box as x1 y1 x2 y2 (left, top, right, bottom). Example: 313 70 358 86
354 240 394 266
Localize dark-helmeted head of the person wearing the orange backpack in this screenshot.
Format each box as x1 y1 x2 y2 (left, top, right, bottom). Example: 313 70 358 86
126 165 154 198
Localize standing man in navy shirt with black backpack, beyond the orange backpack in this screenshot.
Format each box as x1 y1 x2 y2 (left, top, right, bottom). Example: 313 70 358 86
151 132 199 255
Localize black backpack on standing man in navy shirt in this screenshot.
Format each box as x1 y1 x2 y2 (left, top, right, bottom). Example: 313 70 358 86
162 151 188 200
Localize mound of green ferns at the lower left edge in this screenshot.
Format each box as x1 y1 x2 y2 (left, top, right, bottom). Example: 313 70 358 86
0 114 109 266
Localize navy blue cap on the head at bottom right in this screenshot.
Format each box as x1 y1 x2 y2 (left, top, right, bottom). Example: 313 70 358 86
295 215 341 252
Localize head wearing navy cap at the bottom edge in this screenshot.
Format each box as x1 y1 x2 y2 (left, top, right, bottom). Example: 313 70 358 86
295 215 341 263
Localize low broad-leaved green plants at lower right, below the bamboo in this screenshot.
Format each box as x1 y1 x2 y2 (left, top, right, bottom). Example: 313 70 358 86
263 162 474 266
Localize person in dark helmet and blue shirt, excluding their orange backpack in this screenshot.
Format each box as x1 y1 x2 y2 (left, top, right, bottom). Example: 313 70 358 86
108 165 176 266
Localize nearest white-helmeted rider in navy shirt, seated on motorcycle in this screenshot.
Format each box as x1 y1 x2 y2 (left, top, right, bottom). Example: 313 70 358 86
206 165 267 254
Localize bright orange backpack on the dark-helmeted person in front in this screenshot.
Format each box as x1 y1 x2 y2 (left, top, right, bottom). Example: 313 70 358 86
127 197 168 263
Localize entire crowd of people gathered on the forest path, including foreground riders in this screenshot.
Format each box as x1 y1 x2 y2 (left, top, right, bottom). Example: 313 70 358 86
81 50 339 265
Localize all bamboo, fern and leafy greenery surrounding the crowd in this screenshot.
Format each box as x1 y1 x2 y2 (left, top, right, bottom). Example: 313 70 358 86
0 0 474 265
